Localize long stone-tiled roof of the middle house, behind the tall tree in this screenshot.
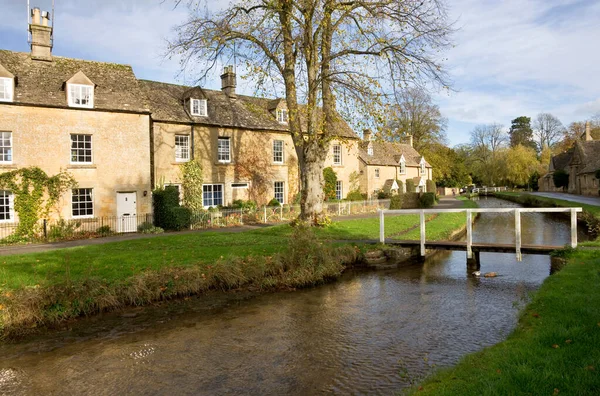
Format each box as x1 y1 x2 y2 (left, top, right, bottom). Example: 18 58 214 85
140 80 358 139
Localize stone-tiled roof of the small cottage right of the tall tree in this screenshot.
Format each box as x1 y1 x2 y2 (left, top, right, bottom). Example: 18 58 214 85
358 140 431 168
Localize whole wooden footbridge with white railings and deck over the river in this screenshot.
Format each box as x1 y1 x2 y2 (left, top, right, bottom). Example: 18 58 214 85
379 208 582 268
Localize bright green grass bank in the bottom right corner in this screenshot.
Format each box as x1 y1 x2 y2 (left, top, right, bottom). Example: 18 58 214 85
411 250 600 395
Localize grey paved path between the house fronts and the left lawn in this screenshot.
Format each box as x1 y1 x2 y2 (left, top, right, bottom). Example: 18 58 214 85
0 197 462 256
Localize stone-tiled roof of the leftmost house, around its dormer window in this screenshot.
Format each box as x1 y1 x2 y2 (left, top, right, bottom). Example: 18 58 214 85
0 50 148 112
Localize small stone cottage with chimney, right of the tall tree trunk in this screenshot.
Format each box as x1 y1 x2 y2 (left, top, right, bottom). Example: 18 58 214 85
358 130 432 196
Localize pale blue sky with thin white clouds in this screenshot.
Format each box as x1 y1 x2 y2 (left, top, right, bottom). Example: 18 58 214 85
0 0 600 145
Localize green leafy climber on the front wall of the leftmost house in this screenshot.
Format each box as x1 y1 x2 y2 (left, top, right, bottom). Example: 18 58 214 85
0 166 77 238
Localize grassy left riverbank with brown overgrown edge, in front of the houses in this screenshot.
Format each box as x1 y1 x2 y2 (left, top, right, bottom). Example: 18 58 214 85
0 201 474 337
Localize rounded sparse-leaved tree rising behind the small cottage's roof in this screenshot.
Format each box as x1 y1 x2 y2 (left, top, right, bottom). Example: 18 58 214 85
382 87 448 151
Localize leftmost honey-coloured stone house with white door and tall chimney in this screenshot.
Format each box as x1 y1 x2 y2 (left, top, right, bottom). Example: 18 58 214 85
0 9 152 232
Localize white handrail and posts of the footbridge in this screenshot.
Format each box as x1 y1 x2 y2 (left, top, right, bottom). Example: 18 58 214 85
379 207 583 261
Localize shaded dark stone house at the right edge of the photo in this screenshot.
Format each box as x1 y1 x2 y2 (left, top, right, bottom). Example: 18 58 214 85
538 123 600 195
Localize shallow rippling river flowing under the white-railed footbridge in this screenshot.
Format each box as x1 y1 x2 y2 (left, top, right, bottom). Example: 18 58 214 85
0 199 584 395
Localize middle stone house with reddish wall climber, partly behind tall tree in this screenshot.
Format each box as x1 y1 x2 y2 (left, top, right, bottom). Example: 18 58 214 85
140 67 358 207
